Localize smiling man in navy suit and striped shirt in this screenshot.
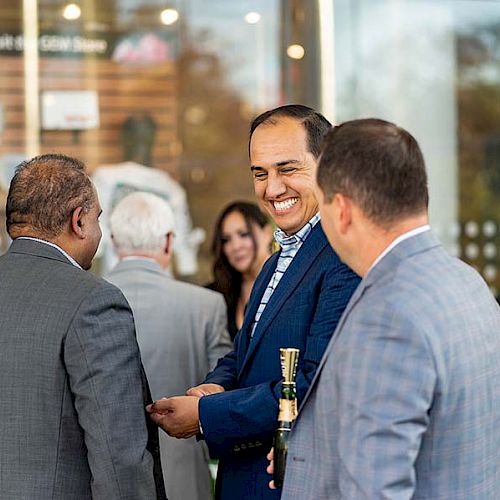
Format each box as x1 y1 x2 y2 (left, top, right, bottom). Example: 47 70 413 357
150 105 359 500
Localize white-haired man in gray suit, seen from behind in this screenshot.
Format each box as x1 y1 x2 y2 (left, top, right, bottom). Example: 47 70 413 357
107 192 231 500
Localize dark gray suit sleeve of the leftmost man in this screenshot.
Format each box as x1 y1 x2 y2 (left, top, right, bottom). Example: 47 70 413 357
64 283 157 499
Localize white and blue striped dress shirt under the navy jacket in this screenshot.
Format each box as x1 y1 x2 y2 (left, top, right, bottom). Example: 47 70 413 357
251 212 320 338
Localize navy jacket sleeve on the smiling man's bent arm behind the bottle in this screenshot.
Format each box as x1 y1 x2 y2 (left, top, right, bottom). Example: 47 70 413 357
199 261 359 456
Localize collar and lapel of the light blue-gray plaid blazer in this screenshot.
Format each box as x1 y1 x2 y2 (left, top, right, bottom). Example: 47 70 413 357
299 231 440 413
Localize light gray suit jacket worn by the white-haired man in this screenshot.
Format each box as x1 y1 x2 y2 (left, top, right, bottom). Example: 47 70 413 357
107 259 231 500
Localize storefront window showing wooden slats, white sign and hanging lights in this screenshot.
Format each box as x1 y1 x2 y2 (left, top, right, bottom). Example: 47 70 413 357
0 0 313 282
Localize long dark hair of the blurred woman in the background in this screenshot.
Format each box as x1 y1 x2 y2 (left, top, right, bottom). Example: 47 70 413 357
212 201 269 305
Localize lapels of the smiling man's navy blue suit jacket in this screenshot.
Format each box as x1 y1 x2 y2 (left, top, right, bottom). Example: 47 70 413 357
239 223 327 375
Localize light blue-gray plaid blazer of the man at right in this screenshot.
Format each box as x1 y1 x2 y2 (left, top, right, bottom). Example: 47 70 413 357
282 232 500 500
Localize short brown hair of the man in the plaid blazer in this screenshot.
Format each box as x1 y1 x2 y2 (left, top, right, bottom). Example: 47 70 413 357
318 118 429 225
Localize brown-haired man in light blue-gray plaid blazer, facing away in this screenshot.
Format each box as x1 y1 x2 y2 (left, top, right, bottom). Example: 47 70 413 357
282 119 500 500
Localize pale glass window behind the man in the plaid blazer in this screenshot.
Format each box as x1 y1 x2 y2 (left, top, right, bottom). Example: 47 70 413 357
335 0 500 293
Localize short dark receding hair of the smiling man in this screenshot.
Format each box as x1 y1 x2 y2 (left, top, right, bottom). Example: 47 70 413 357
248 104 332 158
